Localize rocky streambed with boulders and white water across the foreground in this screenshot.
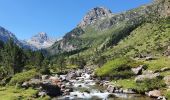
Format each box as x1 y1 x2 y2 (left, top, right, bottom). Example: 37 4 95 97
22 69 159 100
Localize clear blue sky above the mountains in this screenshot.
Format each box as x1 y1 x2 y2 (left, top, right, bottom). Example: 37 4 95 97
0 0 151 39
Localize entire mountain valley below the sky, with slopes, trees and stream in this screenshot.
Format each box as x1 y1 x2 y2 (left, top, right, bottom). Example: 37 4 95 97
0 0 170 100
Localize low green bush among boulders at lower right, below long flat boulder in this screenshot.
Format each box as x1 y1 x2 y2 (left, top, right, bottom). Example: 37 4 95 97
134 78 166 94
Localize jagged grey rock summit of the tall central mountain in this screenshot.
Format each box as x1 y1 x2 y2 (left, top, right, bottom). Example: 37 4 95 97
78 7 112 28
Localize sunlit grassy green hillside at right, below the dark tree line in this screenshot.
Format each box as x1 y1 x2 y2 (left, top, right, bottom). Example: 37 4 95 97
104 18 170 56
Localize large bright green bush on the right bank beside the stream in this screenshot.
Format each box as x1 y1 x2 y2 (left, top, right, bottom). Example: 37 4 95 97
96 58 133 78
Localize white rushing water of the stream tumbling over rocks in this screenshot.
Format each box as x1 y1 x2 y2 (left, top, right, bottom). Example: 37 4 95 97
57 73 154 100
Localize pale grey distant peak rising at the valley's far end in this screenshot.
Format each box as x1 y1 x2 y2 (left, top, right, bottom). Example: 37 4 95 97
27 32 55 49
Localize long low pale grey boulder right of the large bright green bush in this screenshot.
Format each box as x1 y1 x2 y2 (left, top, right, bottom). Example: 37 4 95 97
135 73 160 82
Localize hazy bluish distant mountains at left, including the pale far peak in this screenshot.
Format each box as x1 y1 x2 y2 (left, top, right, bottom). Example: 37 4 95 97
0 26 55 50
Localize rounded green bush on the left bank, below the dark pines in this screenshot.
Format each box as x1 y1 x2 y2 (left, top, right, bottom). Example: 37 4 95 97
9 69 39 85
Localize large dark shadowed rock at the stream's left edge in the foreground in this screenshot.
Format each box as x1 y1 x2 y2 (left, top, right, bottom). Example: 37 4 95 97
41 83 62 97
